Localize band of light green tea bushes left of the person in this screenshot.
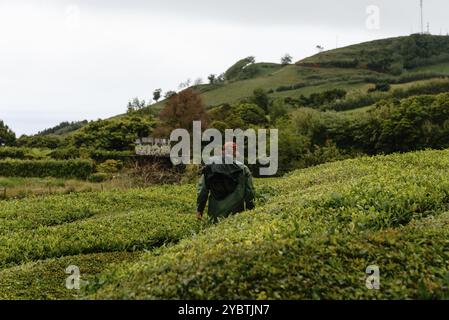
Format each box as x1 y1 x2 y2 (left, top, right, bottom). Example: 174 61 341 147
0 186 201 268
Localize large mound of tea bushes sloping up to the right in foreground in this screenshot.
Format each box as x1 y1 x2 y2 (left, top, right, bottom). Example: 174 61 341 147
88 151 449 299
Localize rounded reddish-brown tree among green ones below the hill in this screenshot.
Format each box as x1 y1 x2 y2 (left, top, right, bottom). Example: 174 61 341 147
157 88 209 135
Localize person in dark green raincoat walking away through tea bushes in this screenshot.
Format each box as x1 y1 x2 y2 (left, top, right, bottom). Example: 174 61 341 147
197 142 255 222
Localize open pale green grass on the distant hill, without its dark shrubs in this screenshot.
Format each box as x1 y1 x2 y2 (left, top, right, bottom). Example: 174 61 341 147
103 35 449 122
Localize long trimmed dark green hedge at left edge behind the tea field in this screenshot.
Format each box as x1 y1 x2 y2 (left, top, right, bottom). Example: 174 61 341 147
0 160 93 179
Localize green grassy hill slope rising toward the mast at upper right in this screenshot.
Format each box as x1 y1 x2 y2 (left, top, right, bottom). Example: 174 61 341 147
144 35 449 114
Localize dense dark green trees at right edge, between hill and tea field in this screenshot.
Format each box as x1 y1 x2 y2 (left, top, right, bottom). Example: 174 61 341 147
315 94 449 154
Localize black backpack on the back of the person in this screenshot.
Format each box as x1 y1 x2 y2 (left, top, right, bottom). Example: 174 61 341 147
203 159 243 200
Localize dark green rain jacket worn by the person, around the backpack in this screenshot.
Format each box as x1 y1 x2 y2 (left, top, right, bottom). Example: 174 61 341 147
197 157 255 222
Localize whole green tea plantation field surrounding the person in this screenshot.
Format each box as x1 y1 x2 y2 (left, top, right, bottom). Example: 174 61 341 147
0 150 449 299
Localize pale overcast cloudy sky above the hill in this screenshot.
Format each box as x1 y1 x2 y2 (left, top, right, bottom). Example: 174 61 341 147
0 0 449 135
